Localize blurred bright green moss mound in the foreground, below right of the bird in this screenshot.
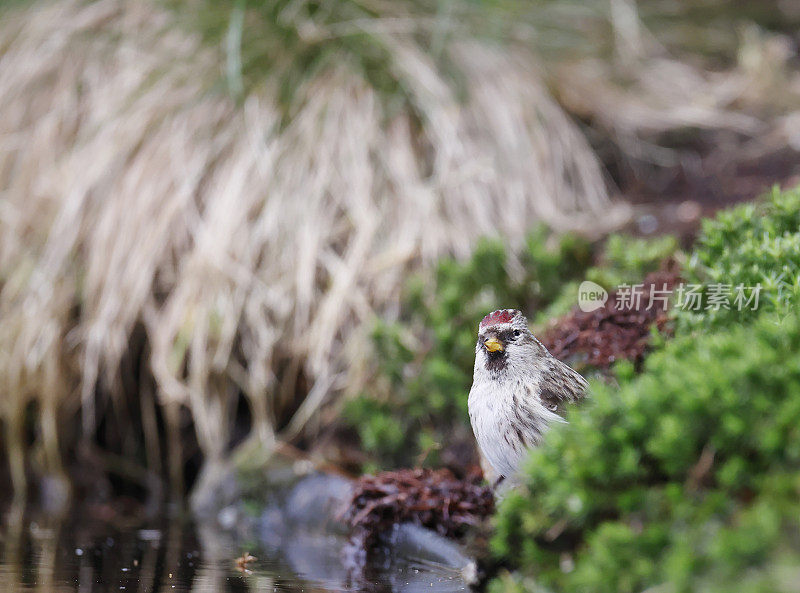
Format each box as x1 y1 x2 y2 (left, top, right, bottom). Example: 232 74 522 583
493 313 800 593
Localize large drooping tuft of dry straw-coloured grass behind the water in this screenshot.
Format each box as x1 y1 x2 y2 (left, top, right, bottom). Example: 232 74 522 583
0 0 626 498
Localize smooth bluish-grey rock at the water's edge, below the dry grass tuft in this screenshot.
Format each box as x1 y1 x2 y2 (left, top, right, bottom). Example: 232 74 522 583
195 450 478 593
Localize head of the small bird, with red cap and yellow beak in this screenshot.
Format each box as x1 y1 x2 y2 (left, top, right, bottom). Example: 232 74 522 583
475 309 543 375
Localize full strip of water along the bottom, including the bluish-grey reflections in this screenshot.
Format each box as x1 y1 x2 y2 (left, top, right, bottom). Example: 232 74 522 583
0 502 466 593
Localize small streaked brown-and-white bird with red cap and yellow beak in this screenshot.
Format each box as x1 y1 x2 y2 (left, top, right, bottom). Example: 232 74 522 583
469 309 588 486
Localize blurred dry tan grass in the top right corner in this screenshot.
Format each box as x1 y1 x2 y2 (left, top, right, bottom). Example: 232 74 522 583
550 0 800 176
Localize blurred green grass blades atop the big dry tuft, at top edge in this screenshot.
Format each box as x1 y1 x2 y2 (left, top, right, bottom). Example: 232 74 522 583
178 0 513 117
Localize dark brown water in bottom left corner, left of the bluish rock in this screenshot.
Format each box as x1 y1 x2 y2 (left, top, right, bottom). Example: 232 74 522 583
0 504 220 593
